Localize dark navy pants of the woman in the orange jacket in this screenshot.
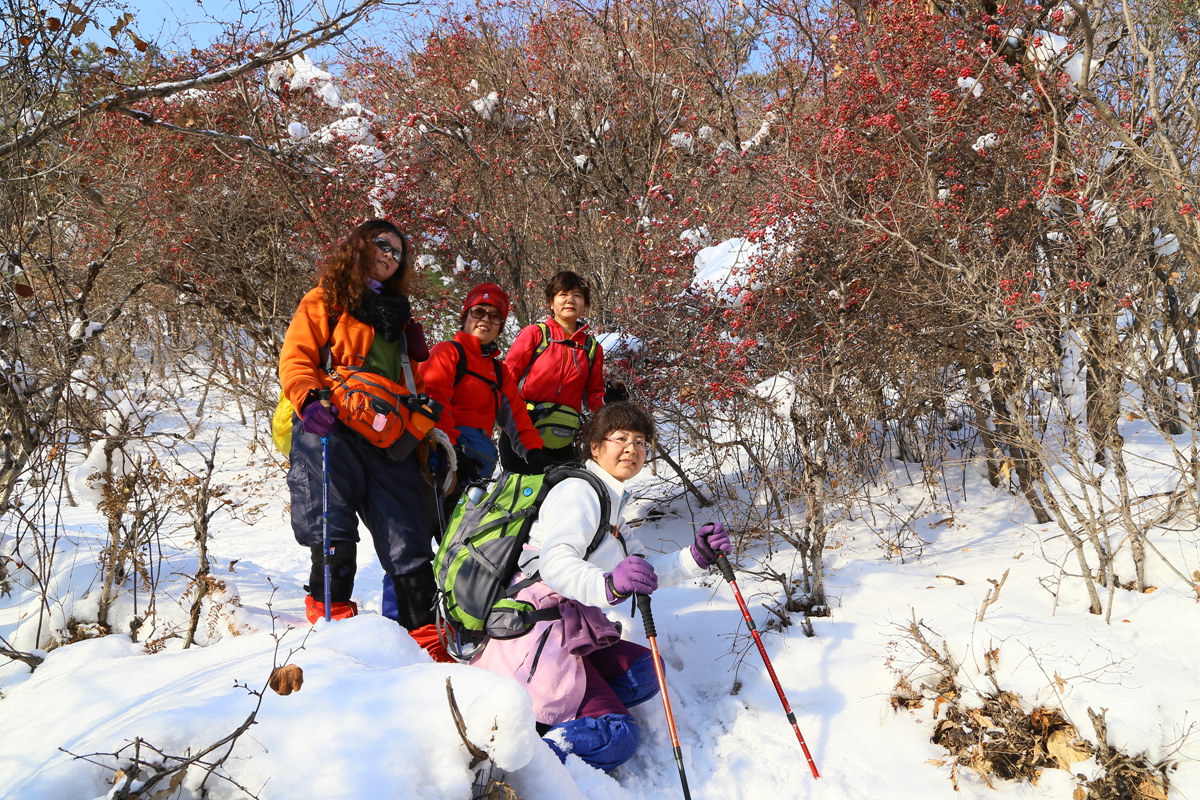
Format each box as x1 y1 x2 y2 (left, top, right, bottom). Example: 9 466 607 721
288 417 437 627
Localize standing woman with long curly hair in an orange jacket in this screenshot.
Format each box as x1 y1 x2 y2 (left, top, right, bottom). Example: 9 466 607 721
280 219 448 657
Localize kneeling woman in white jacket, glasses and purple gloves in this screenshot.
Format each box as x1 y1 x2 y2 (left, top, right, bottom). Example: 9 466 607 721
474 403 730 770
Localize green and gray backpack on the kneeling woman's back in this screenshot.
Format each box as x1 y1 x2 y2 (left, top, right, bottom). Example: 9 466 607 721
433 464 614 662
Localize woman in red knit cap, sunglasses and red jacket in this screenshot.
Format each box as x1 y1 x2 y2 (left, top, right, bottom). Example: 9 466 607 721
421 283 551 518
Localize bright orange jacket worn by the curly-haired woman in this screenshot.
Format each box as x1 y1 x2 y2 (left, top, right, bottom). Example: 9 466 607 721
280 287 422 411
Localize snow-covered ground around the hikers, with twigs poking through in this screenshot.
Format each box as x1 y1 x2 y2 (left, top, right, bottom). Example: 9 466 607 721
0 386 1200 800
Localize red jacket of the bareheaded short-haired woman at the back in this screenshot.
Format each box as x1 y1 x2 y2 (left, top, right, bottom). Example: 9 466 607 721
504 315 604 411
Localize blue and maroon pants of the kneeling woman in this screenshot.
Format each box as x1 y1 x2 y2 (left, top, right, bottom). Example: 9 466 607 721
544 642 659 772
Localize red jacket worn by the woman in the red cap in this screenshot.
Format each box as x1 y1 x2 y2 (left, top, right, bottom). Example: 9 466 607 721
420 331 541 450
